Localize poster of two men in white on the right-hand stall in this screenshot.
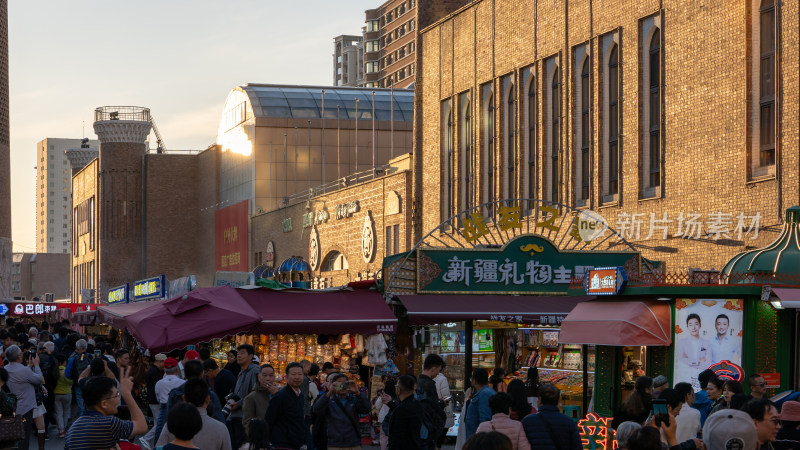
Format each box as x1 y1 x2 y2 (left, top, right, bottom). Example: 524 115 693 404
672 299 742 391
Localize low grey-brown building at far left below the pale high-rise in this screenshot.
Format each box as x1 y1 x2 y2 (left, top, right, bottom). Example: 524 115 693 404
11 253 70 302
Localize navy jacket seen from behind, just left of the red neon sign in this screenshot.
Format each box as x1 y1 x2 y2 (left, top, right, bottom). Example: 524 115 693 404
522 405 583 450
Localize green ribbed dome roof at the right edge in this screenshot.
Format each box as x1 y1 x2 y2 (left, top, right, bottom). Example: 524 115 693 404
722 206 800 284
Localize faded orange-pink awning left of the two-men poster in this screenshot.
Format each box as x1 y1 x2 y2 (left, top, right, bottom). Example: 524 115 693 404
558 300 672 346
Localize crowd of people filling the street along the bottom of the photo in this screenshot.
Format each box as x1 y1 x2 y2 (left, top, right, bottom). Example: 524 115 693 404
0 319 800 450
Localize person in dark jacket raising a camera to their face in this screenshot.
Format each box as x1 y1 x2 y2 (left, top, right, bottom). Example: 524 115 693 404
313 373 371 450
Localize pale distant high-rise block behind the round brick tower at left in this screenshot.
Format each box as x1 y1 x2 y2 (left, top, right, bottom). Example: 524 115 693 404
36 138 100 253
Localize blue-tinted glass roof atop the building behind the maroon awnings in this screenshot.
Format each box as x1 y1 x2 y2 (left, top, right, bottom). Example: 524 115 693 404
241 84 414 122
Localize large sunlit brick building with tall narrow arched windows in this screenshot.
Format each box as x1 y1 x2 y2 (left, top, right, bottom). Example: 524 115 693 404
414 0 800 271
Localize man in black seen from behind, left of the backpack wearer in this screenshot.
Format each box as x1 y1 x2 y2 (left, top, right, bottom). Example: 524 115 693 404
385 375 426 450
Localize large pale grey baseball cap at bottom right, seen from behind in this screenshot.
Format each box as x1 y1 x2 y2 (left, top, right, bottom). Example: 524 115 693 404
703 409 758 450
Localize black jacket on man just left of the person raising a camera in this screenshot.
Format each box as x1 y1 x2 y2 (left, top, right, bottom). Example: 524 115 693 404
264 386 306 450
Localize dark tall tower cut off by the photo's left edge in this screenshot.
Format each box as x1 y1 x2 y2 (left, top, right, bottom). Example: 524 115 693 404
0 0 11 298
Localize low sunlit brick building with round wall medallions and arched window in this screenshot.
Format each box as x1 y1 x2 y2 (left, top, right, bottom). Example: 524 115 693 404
251 154 411 288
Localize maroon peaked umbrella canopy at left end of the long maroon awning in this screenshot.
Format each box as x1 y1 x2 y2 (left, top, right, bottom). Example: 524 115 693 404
127 286 261 353
